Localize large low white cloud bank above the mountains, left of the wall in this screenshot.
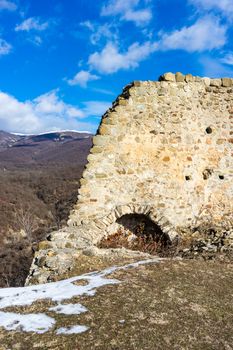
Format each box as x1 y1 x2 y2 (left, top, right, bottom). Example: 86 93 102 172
0 91 109 134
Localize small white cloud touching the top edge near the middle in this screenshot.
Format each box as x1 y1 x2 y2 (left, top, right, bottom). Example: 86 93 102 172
101 0 152 26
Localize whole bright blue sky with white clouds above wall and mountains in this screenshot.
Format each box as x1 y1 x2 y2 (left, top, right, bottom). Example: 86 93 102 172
0 0 233 133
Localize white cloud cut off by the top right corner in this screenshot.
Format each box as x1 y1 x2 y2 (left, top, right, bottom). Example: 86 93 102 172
189 0 233 18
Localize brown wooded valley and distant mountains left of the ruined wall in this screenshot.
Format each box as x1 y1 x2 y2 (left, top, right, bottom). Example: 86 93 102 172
0 131 92 287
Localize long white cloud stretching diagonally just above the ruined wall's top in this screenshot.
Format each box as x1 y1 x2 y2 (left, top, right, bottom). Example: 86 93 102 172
85 15 228 74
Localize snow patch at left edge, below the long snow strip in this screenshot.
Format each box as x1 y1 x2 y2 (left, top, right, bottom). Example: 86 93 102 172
0 311 56 334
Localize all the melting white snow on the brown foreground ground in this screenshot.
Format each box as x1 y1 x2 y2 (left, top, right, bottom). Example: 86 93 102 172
0 258 163 334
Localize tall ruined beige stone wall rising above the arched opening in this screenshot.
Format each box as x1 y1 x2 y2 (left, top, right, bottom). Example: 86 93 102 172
68 73 233 239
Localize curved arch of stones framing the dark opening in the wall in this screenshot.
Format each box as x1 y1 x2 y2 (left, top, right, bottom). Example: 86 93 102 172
92 204 178 242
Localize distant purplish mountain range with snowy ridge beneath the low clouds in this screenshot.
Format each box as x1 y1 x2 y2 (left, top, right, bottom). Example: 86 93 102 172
0 131 93 169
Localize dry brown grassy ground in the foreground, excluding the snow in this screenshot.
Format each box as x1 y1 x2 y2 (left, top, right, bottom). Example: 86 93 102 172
0 260 233 350
